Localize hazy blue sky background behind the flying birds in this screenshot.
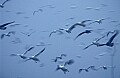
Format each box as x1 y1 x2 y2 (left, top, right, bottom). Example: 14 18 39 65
0 0 120 78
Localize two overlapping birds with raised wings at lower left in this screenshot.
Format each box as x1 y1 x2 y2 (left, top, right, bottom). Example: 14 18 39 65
10 47 46 63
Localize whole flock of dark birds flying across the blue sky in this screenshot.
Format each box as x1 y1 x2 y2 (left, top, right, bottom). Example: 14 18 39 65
0 0 119 74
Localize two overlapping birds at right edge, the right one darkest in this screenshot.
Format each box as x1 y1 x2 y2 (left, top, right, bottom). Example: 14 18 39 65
83 30 119 50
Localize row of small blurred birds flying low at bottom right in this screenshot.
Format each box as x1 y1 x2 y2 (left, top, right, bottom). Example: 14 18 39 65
79 66 108 73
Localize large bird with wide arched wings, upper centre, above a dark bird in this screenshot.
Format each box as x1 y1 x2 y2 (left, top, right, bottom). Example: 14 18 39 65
60 20 92 33
